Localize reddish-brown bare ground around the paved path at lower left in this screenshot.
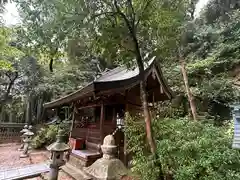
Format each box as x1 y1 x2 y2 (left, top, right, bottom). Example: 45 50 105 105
0 143 73 180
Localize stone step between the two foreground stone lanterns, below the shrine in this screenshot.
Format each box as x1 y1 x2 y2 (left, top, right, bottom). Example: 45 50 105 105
62 163 92 180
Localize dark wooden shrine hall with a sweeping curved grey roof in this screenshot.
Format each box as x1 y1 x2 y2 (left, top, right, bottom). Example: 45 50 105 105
44 57 173 166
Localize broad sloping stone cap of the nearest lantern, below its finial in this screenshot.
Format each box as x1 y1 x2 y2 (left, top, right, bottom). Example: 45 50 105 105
83 158 128 180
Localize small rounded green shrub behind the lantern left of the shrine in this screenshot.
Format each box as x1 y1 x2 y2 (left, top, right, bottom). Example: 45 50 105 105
32 124 69 149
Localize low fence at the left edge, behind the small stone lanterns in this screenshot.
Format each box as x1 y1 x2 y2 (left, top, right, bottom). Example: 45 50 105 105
0 123 25 143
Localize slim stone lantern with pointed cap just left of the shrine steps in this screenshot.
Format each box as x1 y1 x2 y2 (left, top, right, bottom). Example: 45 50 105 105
47 130 70 180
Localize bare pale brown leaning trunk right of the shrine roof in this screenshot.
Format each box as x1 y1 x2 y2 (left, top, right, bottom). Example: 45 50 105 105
180 56 197 121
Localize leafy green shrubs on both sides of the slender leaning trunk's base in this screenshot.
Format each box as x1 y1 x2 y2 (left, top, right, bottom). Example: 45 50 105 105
126 114 240 180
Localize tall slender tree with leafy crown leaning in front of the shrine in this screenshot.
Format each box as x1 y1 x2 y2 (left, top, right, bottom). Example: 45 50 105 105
82 0 186 158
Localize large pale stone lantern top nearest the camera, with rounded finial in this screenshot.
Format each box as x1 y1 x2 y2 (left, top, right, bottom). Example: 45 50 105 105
84 135 128 180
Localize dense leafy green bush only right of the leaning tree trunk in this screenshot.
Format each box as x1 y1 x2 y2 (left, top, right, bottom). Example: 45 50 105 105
154 119 240 180
